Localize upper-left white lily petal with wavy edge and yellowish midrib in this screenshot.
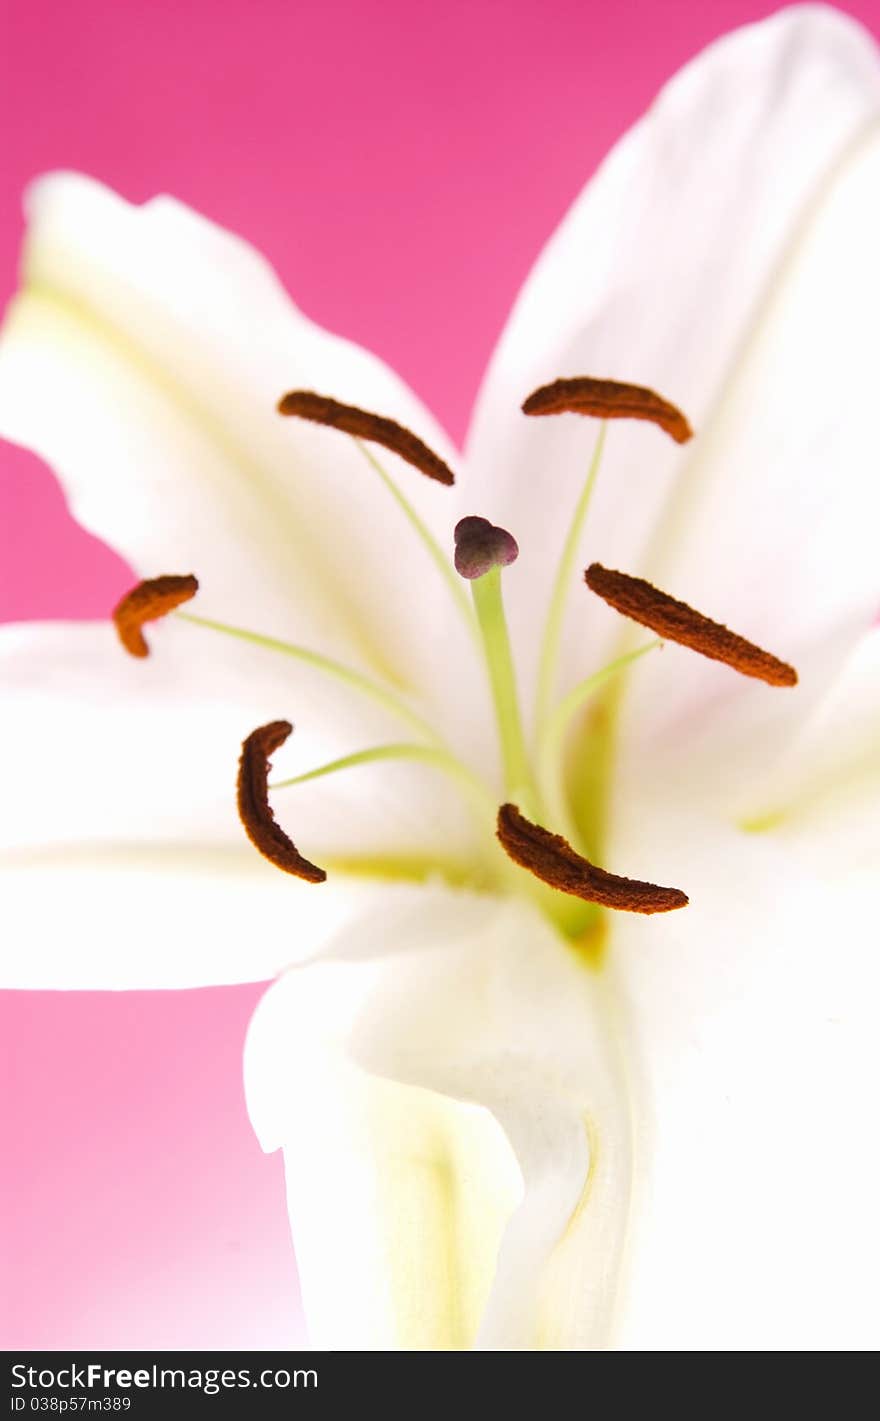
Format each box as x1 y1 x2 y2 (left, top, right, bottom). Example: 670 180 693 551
0 175 486 755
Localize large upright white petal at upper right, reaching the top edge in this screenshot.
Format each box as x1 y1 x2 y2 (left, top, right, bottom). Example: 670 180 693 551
469 6 880 716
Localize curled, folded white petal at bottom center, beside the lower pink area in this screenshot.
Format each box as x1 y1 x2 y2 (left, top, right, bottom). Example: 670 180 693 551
246 894 630 1349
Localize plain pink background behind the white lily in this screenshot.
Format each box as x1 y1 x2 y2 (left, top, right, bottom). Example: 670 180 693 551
0 0 880 1349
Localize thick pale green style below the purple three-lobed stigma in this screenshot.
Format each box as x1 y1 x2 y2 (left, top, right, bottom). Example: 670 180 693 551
471 567 540 816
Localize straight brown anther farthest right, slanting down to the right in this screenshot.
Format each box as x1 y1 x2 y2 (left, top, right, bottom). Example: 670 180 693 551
584 563 798 686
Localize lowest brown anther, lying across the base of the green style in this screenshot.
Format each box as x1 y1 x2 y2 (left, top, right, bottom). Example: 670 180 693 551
498 804 688 912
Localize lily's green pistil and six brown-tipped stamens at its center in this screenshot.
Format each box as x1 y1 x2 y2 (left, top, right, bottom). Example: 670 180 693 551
114 377 798 941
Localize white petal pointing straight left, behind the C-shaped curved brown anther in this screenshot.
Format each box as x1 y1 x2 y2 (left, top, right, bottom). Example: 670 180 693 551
0 620 479 989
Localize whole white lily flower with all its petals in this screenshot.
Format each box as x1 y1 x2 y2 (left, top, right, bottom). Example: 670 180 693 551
0 6 880 1349
